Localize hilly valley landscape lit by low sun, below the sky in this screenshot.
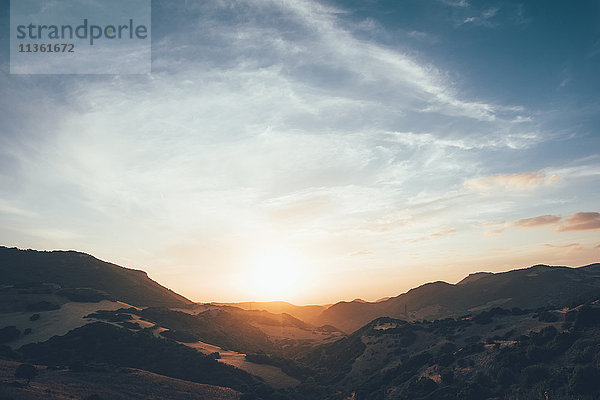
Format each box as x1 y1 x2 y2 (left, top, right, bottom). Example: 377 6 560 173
0 248 600 400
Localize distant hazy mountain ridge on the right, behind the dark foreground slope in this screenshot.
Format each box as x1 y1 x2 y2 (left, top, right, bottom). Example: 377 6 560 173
317 264 600 333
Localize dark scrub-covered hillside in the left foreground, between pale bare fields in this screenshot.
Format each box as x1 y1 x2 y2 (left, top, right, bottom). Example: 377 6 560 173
20 322 282 393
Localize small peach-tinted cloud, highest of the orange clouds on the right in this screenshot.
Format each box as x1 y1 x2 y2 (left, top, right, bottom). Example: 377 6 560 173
464 172 560 192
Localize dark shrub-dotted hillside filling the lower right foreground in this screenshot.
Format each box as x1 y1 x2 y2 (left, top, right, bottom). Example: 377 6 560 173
303 298 600 400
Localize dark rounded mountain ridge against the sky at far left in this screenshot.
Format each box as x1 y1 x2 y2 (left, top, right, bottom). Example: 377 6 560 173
0 246 192 307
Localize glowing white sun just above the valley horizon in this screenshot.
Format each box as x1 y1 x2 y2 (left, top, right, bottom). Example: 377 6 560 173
245 251 304 300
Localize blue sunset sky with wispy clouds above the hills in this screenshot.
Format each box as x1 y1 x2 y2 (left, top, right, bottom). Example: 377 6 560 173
0 0 600 304
